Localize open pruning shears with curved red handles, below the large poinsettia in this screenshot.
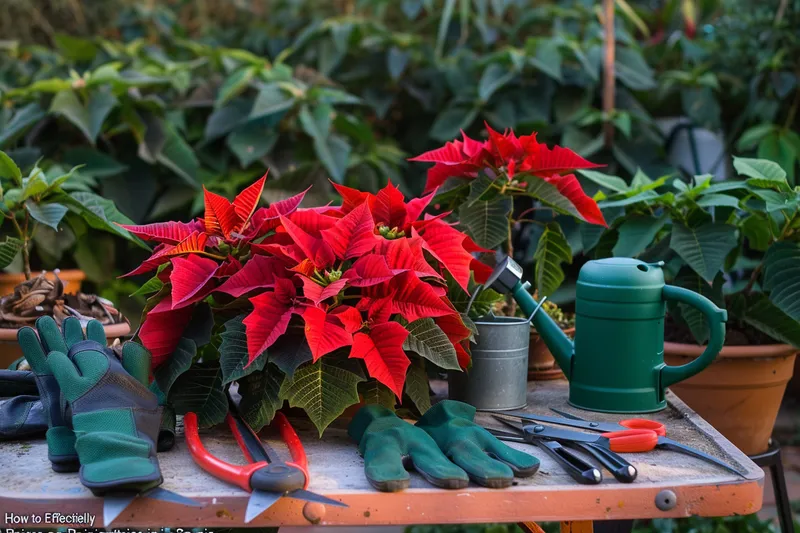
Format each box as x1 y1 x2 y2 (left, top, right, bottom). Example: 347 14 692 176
188 402 347 523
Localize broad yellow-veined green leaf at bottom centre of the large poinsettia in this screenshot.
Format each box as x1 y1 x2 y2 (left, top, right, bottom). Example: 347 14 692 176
280 357 364 437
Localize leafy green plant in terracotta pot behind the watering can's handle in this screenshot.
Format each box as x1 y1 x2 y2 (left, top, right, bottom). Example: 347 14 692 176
584 158 800 454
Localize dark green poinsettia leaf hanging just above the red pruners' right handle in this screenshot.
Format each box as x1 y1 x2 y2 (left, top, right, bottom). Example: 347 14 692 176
238 357 286 431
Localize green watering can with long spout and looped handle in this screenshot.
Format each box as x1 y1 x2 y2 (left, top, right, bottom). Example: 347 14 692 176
484 257 728 413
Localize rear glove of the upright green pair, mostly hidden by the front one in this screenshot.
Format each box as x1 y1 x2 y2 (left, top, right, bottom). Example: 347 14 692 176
17 317 87 472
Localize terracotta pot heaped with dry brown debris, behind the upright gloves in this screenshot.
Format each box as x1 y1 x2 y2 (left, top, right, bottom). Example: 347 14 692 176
0 273 131 368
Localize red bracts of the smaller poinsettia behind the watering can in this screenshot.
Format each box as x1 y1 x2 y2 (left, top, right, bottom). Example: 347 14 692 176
410 124 606 226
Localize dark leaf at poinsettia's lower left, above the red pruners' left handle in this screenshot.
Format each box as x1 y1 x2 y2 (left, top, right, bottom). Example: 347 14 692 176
169 364 228 428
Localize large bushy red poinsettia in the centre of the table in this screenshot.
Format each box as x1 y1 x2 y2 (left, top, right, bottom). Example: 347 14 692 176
125 176 491 434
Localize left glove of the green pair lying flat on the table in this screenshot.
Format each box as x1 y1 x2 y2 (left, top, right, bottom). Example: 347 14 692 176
347 405 469 492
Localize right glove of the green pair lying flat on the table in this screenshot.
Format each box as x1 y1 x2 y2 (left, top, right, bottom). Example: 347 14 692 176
416 400 539 488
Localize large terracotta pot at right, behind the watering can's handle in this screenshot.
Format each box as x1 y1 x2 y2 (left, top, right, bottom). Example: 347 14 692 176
664 342 798 455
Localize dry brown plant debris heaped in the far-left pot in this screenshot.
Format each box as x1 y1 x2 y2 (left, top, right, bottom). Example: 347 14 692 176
0 272 125 328
